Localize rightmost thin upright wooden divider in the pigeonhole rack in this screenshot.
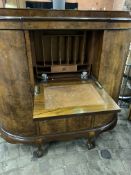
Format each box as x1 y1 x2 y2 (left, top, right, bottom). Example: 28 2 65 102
80 32 86 64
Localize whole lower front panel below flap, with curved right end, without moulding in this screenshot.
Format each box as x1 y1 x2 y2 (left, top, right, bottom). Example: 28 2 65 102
39 113 114 135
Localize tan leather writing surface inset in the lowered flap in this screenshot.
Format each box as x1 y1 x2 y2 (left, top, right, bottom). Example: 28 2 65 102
44 84 104 109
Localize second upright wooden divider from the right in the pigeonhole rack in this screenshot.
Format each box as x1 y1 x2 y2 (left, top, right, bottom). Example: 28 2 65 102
73 36 79 64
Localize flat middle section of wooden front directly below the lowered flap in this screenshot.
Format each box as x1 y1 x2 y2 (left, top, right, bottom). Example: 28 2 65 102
39 116 92 135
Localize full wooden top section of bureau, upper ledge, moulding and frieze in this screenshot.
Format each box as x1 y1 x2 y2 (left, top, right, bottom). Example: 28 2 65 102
0 9 131 30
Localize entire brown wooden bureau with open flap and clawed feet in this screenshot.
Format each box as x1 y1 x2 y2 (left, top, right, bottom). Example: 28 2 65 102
0 9 131 157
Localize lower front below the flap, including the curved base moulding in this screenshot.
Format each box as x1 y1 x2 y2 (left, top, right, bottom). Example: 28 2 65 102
1 114 117 144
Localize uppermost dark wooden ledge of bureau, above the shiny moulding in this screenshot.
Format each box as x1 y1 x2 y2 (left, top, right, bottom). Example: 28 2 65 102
0 8 131 20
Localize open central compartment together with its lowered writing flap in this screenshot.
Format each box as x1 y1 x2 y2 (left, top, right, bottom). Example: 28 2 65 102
30 30 119 119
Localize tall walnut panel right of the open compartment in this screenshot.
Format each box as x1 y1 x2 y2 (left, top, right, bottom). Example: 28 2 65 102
98 30 131 101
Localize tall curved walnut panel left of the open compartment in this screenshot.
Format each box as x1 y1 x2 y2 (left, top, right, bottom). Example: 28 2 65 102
0 30 35 136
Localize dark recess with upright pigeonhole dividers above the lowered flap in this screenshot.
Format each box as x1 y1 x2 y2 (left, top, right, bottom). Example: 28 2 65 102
30 30 103 81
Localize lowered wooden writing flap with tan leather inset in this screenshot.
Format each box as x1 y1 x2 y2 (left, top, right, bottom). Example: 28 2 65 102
33 81 120 119
